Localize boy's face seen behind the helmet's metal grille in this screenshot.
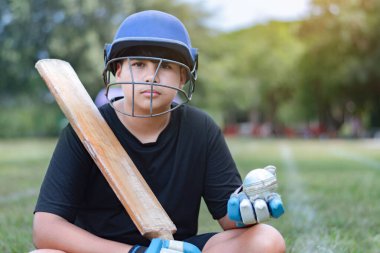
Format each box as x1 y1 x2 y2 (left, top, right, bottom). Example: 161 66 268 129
115 57 187 115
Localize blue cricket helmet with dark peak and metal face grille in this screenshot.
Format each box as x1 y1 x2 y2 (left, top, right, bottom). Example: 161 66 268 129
103 10 198 117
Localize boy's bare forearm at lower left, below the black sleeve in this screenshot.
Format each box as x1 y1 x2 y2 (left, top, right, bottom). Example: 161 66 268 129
33 212 132 253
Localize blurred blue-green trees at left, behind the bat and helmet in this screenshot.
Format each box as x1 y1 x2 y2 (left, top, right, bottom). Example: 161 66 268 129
0 0 208 136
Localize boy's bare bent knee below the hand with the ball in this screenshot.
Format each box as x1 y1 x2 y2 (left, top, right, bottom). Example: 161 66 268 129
202 224 285 253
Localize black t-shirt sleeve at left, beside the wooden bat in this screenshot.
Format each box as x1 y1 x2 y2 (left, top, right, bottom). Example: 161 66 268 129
35 125 93 222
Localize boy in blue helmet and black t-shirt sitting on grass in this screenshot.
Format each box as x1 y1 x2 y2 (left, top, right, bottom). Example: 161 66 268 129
33 11 285 253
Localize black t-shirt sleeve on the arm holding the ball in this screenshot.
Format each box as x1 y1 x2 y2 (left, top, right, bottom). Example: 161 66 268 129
203 116 241 219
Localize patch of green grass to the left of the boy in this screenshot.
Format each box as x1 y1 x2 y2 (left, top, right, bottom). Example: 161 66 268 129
0 140 55 253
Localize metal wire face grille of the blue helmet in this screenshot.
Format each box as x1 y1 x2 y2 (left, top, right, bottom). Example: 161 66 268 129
103 56 196 118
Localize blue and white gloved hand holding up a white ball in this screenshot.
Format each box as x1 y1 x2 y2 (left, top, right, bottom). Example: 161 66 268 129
227 166 285 227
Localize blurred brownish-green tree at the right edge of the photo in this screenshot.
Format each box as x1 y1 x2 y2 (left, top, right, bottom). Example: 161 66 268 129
297 0 380 134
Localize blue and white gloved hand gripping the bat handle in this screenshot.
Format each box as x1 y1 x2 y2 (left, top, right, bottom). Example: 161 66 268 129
129 238 201 253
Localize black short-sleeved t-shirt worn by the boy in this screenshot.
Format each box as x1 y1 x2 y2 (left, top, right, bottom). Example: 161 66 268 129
35 104 241 245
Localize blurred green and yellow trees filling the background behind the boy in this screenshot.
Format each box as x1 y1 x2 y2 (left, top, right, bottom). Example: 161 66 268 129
0 0 380 137
